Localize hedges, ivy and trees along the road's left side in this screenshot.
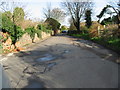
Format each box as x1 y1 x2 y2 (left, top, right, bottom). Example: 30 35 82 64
0 2 63 53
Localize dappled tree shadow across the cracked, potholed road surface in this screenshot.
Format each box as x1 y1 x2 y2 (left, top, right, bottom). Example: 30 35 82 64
11 41 120 88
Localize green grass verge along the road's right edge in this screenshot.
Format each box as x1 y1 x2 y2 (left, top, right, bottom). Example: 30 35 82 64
69 33 120 54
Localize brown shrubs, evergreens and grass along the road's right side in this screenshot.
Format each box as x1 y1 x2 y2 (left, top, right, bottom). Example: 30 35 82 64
68 1 120 54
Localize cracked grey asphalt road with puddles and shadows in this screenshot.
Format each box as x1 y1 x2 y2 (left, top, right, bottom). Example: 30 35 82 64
2 35 118 88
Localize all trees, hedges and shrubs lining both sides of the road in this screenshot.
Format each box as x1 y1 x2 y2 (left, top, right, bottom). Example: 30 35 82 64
0 0 120 52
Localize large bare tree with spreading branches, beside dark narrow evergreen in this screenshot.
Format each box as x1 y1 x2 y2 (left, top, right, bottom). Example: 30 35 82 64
62 0 92 32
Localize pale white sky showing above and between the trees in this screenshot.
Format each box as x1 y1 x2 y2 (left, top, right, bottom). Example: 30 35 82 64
1 0 117 26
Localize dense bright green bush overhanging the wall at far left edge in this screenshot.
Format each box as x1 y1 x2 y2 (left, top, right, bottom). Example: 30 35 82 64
2 12 24 44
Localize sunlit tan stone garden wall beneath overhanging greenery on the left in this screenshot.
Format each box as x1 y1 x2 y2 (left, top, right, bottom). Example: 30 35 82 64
2 32 51 52
